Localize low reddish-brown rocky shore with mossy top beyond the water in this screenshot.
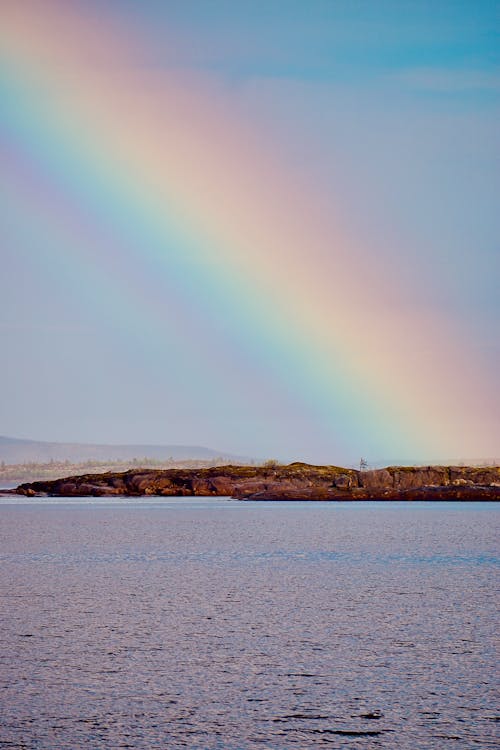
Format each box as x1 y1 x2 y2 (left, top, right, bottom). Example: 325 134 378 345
11 463 500 500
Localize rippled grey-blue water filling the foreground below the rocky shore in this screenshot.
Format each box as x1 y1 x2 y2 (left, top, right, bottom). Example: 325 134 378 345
0 498 499 750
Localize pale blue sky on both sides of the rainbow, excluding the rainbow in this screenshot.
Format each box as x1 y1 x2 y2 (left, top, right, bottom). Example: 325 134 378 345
0 0 500 461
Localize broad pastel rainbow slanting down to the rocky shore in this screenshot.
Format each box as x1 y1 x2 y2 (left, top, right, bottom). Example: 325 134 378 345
0 0 498 459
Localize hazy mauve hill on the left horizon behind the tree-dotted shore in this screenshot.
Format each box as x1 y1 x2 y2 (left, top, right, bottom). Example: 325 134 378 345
0 436 244 464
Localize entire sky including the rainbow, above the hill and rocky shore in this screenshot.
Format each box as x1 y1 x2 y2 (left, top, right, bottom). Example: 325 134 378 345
0 0 500 464
